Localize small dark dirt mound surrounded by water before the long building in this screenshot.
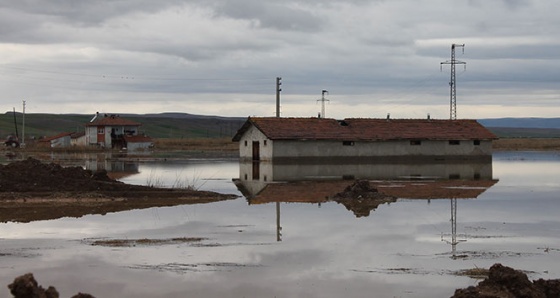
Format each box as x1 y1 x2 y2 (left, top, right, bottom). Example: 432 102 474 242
332 180 397 217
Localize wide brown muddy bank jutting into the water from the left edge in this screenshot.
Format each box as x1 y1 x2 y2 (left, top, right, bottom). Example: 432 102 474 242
0 158 236 222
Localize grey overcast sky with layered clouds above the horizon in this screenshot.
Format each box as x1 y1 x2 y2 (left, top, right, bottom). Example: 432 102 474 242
0 0 560 119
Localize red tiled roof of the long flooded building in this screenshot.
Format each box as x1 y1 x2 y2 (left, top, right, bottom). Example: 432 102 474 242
233 117 497 141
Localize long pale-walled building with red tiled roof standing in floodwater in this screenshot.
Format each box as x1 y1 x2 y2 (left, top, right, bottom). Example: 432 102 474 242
233 117 497 163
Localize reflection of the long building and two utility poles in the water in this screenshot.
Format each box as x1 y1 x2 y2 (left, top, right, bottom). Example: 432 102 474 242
235 161 496 242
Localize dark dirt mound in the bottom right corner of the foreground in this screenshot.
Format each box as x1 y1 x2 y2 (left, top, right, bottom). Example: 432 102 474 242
451 264 560 298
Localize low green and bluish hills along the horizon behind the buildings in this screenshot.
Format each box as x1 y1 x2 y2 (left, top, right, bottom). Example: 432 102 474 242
0 111 560 139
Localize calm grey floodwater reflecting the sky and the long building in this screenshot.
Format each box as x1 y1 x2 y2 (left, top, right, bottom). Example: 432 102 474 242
0 152 560 298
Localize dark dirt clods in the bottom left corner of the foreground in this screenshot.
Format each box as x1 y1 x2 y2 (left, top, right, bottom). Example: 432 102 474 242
8 273 95 298
